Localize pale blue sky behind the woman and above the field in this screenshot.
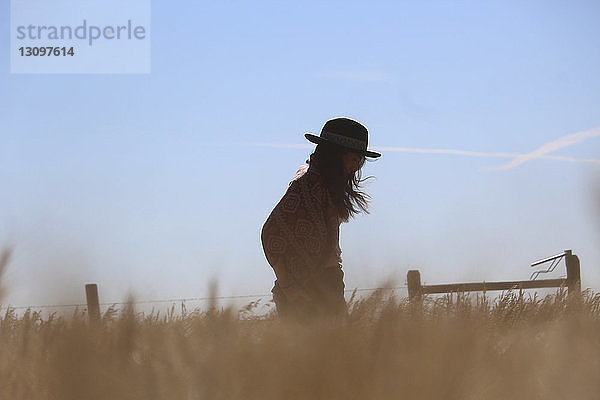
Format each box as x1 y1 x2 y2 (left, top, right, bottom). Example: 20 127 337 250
0 1 600 305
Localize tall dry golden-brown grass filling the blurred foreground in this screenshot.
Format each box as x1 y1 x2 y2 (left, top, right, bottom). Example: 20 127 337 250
0 282 600 400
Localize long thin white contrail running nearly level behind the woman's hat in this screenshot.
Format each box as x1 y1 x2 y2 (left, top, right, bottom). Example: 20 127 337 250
251 142 600 169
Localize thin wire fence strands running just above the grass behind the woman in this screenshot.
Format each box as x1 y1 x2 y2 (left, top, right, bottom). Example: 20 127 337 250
0 285 408 310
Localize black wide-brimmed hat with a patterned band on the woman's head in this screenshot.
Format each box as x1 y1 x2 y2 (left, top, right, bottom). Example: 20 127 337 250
304 118 381 158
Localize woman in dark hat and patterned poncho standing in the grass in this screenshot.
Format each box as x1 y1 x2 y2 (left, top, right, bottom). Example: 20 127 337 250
261 118 381 320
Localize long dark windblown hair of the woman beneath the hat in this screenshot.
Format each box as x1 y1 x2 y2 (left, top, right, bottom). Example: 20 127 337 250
310 143 372 222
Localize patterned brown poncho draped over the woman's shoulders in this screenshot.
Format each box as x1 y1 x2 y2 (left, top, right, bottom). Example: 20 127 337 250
261 160 342 298
